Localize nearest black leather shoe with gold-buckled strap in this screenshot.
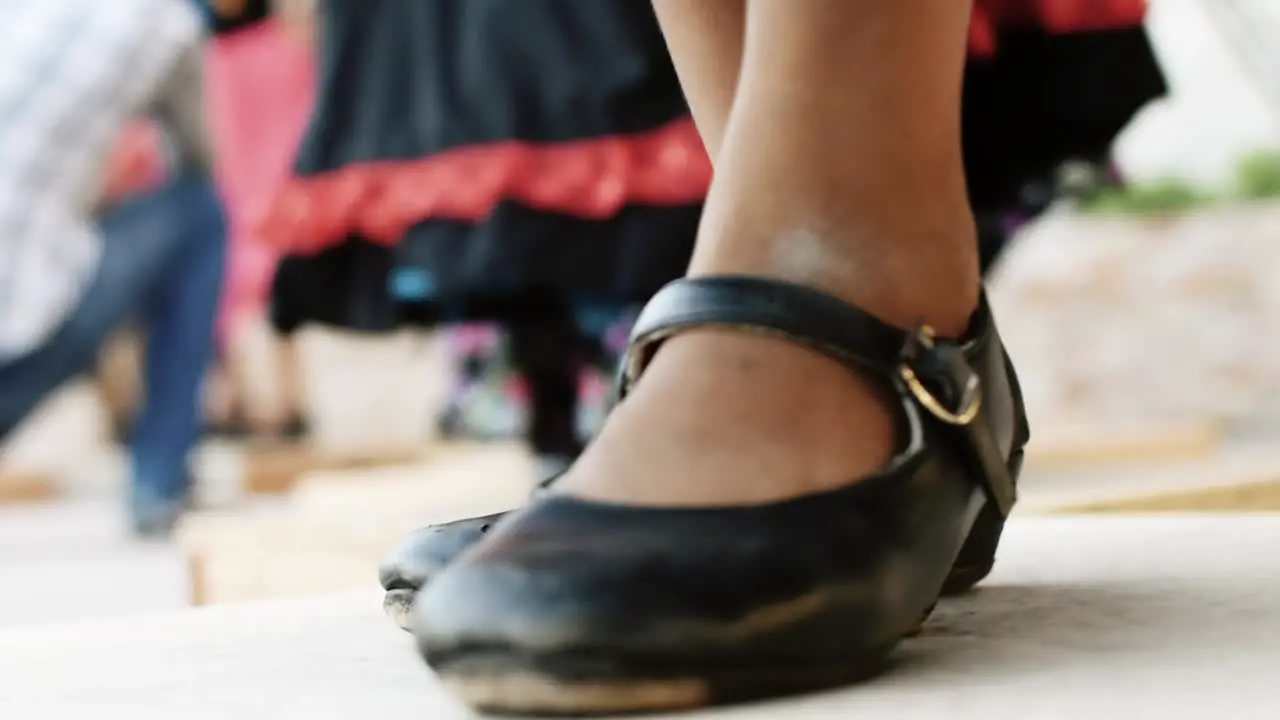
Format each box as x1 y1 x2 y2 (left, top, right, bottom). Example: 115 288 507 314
412 277 1027 714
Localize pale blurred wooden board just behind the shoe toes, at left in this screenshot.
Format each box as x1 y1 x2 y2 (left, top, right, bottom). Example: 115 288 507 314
178 445 534 605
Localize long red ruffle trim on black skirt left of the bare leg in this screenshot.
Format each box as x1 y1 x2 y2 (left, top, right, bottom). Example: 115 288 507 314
256 118 712 254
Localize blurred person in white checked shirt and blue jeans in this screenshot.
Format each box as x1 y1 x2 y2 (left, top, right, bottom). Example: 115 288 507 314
0 0 225 536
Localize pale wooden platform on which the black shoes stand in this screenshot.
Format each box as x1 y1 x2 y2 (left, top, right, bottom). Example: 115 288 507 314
0 515 1280 720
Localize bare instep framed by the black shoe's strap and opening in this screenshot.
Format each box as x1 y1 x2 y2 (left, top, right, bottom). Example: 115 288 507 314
556 331 893 506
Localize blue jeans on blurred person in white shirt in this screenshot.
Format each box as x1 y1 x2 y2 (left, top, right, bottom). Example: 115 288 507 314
0 177 227 505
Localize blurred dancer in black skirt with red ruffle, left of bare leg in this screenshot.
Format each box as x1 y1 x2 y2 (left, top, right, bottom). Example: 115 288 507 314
262 0 710 474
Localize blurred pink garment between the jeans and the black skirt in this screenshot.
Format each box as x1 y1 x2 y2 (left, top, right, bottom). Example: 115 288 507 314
207 20 315 346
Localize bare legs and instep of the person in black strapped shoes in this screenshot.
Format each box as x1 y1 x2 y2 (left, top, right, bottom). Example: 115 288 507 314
557 0 979 505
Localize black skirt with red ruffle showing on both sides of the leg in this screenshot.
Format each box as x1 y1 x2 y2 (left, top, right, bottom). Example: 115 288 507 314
261 0 1165 331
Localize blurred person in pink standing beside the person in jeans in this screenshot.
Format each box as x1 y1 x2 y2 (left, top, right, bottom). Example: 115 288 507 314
206 0 315 439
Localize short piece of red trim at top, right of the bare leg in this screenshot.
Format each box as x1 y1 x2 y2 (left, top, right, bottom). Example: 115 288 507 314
969 0 1147 56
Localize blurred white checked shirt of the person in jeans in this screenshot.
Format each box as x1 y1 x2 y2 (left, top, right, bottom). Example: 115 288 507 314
0 0 201 361
